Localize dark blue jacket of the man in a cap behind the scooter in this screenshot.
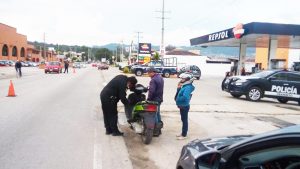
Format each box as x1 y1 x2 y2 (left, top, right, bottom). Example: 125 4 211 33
147 73 164 103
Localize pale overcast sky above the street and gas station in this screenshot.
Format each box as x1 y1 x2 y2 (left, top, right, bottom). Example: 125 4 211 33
0 0 300 46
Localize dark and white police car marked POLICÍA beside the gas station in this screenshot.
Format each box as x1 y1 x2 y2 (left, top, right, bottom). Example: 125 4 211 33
222 70 300 105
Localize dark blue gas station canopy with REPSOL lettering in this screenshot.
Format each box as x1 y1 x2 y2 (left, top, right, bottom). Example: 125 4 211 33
190 22 300 49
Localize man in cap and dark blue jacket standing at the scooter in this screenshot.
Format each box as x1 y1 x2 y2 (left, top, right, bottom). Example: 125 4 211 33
147 67 164 136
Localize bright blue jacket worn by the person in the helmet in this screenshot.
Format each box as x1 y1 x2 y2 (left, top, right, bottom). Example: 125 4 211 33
176 83 195 106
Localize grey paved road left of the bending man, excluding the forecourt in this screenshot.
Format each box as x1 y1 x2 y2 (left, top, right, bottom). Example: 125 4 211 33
0 68 131 169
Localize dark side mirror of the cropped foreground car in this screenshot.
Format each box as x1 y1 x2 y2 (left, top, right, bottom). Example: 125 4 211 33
196 151 221 169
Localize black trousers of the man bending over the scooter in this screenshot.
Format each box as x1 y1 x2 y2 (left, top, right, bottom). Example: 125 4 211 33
101 98 119 133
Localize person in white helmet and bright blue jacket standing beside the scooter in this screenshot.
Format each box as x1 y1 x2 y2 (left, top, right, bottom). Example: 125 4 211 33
175 73 195 140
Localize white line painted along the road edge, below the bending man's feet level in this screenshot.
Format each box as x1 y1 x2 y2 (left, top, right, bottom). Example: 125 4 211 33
93 127 102 169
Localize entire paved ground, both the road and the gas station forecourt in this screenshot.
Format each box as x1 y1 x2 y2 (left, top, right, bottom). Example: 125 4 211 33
0 68 300 169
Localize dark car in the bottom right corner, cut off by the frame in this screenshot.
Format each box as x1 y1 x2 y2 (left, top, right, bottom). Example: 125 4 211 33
176 125 300 169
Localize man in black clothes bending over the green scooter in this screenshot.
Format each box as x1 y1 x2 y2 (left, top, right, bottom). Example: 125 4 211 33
100 75 137 136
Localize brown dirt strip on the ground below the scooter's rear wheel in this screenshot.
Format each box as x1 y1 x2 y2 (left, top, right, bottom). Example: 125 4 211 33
122 126 158 169
